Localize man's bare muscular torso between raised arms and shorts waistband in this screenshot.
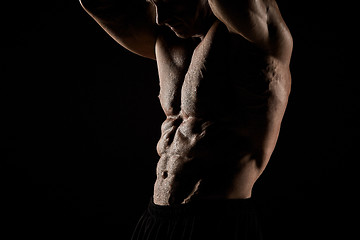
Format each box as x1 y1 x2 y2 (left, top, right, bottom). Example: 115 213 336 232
154 21 290 205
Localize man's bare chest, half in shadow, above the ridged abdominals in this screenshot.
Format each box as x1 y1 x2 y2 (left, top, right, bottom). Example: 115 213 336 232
156 22 267 118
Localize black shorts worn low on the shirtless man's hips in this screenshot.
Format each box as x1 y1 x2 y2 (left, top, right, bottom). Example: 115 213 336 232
132 199 262 240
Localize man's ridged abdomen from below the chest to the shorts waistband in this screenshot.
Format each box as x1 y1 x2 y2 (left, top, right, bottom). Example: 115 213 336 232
153 113 260 205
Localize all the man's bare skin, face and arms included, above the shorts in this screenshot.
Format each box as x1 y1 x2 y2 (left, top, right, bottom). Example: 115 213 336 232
81 0 292 205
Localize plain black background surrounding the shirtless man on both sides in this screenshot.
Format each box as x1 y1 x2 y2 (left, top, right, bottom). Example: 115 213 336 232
0 0 359 239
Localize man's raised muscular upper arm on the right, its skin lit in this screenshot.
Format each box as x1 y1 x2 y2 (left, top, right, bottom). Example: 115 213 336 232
208 0 293 64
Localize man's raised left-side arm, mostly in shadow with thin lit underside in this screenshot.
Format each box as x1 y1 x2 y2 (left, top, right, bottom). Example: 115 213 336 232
80 0 157 59
